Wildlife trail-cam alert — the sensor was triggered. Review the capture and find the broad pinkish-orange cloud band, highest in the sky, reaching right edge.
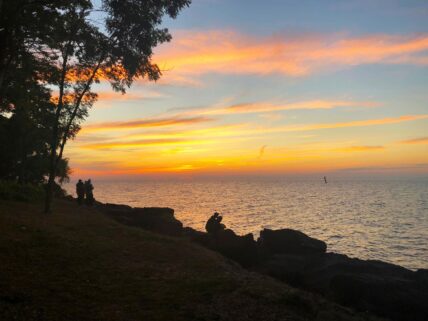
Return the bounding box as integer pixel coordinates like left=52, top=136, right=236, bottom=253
left=155, top=30, right=428, bottom=77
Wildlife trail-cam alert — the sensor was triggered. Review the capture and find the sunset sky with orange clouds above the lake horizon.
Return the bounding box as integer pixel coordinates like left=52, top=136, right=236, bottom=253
left=65, top=0, right=428, bottom=178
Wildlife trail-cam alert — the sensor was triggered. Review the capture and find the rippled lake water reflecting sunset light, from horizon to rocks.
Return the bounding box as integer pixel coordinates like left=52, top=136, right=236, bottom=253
left=66, top=179, right=428, bottom=269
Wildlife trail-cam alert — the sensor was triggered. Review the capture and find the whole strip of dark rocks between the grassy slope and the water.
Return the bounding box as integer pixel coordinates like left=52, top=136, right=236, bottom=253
left=90, top=203, right=428, bottom=321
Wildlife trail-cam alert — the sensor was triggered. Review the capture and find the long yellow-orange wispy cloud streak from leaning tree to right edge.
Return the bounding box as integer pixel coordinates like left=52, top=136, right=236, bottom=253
left=77, top=115, right=428, bottom=143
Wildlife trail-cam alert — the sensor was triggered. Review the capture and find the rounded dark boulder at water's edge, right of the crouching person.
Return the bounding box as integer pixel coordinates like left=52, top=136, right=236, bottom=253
left=258, top=229, right=327, bottom=255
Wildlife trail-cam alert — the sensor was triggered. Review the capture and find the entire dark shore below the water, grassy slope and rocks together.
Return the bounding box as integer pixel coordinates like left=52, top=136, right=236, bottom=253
left=0, top=196, right=428, bottom=321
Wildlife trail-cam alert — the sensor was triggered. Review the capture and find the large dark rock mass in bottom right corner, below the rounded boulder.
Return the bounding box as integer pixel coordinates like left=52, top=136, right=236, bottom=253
left=259, top=253, right=428, bottom=321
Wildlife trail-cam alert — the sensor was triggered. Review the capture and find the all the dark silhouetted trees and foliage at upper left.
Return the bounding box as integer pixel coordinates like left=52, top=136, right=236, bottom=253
left=0, top=0, right=190, bottom=211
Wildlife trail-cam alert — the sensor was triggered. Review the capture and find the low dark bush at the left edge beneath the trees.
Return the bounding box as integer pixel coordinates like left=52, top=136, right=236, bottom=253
left=0, top=181, right=45, bottom=202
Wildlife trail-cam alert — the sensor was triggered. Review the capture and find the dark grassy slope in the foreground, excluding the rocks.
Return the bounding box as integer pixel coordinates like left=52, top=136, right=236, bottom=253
left=0, top=201, right=382, bottom=321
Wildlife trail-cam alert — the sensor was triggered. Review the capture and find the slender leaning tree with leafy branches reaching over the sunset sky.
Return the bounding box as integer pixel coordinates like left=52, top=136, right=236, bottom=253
left=44, top=0, right=190, bottom=212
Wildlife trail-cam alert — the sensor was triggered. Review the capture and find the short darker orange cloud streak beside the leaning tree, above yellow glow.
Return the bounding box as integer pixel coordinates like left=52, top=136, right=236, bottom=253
left=82, top=117, right=212, bottom=132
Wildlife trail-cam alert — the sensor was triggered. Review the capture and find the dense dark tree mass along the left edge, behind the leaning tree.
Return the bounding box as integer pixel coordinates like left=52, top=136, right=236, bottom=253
left=0, top=0, right=81, bottom=183
